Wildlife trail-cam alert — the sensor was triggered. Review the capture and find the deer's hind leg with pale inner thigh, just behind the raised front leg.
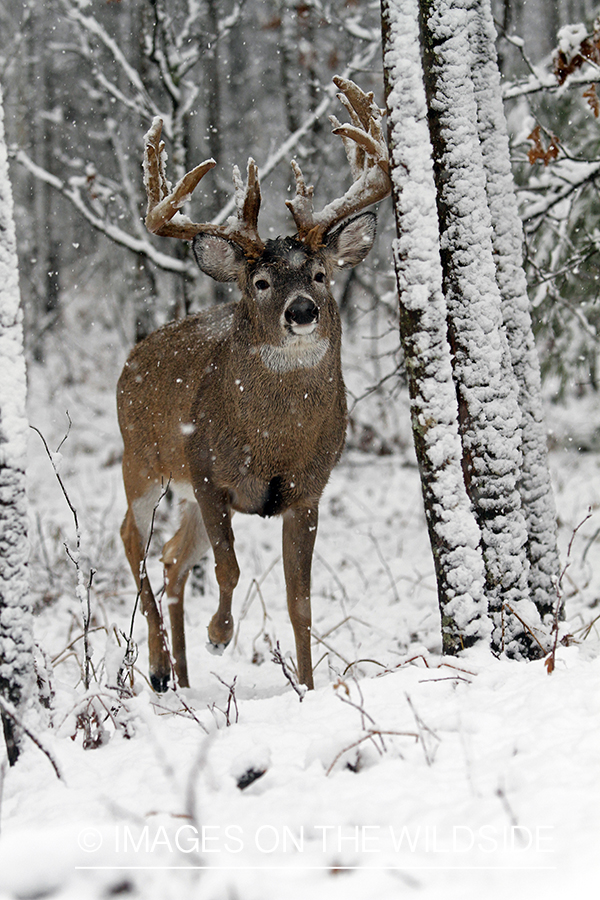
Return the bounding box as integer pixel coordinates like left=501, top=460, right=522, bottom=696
left=162, top=500, right=210, bottom=687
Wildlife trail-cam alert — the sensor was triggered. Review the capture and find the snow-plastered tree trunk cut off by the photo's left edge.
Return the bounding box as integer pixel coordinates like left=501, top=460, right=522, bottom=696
left=0, top=89, right=33, bottom=764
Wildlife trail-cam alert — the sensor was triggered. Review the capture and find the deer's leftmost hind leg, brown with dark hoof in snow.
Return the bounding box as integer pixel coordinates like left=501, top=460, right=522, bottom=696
left=121, top=484, right=171, bottom=693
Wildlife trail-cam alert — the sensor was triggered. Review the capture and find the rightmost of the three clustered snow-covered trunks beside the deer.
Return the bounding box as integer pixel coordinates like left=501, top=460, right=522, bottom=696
left=470, top=0, right=559, bottom=615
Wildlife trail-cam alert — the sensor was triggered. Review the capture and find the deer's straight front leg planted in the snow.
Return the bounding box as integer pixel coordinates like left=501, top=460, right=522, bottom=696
left=283, top=506, right=319, bottom=690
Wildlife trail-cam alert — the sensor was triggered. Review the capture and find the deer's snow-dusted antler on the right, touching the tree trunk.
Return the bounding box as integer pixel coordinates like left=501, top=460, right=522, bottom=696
left=286, top=76, right=391, bottom=247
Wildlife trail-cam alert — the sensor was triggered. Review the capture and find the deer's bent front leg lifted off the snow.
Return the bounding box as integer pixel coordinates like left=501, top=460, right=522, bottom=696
left=196, top=482, right=240, bottom=649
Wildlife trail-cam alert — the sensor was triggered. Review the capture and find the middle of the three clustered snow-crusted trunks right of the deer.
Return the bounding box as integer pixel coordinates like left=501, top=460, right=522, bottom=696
left=420, top=0, right=539, bottom=656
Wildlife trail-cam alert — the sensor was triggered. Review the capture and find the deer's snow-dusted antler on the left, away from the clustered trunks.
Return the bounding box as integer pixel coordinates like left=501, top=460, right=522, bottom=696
left=144, top=117, right=264, bottom=258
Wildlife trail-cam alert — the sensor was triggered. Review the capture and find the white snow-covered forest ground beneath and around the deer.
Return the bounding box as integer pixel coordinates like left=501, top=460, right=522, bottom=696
left=0, top=276, right=600, bottom=900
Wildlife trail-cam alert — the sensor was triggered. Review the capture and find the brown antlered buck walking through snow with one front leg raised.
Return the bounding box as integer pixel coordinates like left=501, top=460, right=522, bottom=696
left=117, top=77, right=390, bottom=693
